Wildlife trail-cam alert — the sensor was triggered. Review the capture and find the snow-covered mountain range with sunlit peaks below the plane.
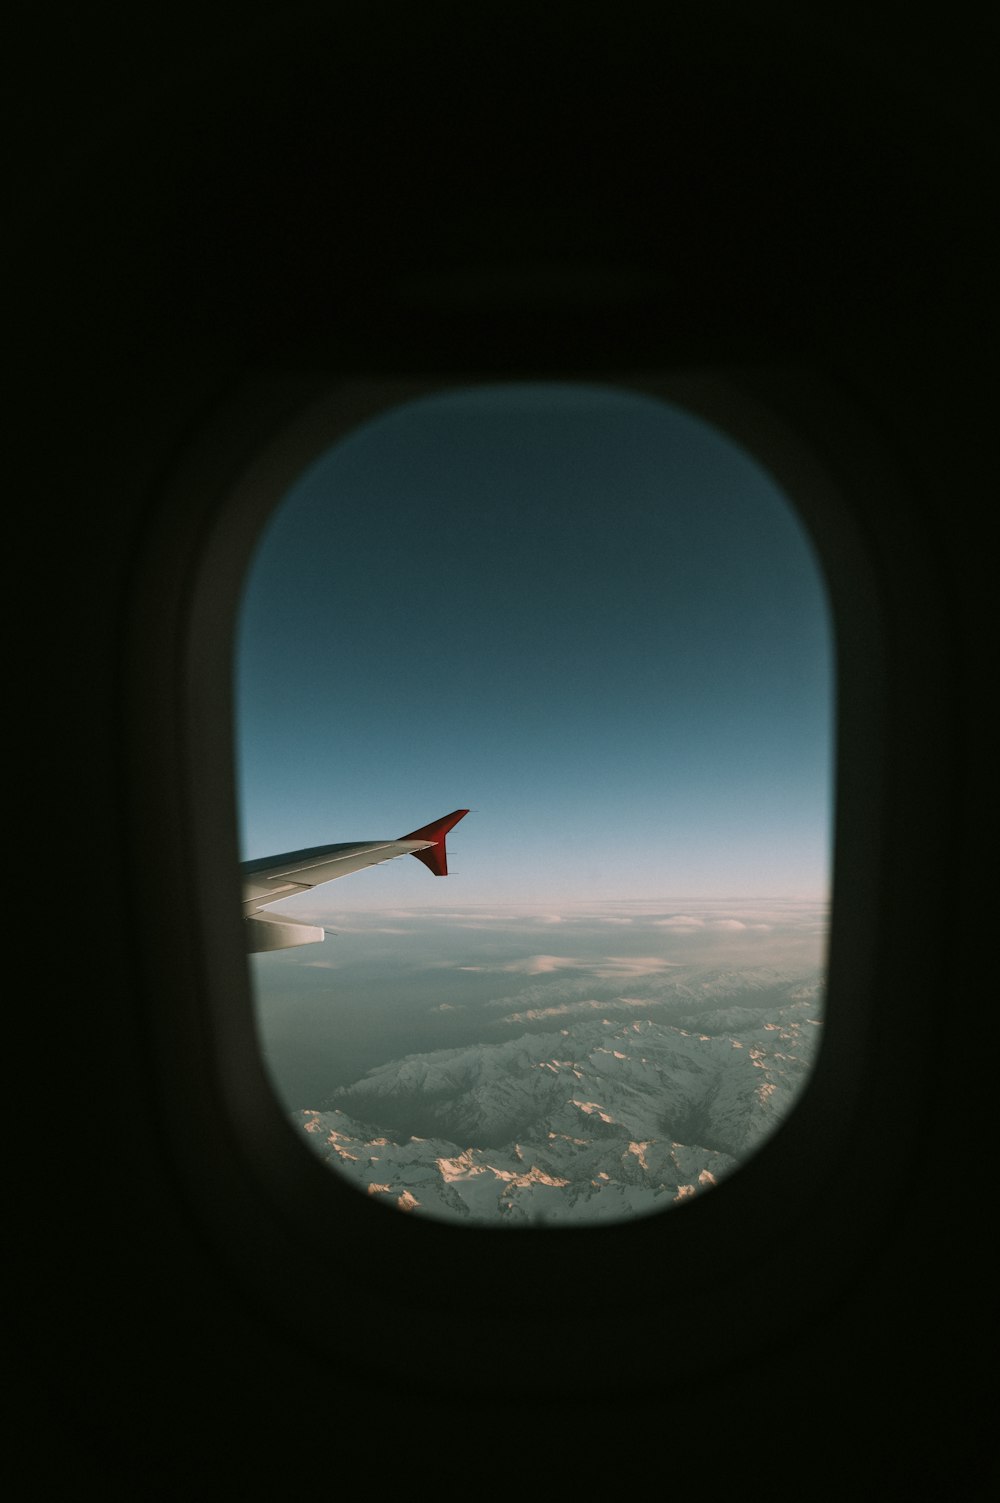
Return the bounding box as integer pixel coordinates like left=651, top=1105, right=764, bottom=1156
left=295, top=972, right=821, bottom=1225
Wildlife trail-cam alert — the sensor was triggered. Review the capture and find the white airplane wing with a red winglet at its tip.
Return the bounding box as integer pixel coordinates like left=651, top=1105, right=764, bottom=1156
left=241, top=809, right=469, bottom=953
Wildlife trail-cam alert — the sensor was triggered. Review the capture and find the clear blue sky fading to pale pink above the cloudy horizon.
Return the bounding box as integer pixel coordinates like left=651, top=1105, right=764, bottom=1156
left=236, top=385, right=833, bottom=912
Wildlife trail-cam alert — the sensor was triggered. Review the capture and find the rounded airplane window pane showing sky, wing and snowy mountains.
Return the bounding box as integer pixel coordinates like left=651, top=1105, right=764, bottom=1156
left=236, top=383, right=835, bottom=1226
